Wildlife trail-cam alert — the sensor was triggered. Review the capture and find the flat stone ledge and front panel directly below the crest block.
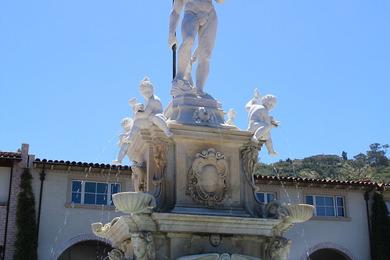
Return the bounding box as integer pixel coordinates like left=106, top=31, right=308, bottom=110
left=152, top=213, right=281, bottom=259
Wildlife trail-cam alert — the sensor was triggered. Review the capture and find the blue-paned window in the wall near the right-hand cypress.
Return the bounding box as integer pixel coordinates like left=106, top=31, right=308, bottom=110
left=306, top=195, right=345, bottom=217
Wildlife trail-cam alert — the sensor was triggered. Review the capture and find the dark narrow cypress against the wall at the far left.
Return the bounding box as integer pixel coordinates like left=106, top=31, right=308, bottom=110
left=14, top=168, right=38, bottom=260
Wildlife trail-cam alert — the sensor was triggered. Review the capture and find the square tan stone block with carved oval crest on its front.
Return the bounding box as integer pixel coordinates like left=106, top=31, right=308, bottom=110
left=165, top=123, right=254, bottom=217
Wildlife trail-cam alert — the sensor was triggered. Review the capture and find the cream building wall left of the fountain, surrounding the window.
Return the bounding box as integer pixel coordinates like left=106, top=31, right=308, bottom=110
left=33, top=169, right=131, bottom=260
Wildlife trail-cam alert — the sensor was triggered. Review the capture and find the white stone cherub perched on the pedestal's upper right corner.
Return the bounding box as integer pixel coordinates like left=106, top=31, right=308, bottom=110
left=245, top=90, right=279, bottom=156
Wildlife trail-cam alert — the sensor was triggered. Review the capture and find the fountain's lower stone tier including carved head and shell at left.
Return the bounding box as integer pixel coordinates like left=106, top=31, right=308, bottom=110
left=92, top=205, right=290, bottom=260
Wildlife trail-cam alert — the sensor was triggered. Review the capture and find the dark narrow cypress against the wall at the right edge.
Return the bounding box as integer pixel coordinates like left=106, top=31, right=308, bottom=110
left=371, top=192, right=390, bottom=260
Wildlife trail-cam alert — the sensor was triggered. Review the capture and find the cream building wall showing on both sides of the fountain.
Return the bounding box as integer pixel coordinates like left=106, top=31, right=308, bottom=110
left=33, top=172, right=370, bottom=260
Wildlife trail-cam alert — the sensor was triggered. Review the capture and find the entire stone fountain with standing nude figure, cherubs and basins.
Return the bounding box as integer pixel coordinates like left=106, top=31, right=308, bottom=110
left=92, top=0, right=314, bottom=260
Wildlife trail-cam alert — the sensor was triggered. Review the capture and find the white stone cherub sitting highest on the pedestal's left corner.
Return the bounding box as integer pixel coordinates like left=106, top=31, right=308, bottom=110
left=126, top=77, right=172, bottom=142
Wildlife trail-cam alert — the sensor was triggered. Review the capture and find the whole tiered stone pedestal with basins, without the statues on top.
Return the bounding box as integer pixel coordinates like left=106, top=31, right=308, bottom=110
left=92, top=88, right=314, bottom=260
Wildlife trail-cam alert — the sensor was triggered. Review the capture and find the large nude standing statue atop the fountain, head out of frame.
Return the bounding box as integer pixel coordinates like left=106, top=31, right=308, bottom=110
left=168, top=0, right=224, bottom=96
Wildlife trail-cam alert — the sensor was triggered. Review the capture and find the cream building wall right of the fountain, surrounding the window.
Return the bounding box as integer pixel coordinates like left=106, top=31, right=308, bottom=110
left=260, top=185, right=370, bottom=260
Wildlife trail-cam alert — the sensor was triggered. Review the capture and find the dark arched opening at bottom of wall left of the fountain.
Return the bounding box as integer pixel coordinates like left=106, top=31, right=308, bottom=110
left=58, top=240, right=112, bottom=260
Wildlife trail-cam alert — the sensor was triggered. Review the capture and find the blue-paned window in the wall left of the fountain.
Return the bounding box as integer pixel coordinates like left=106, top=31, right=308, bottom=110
left=71, top=180, right=121, bottom=205
